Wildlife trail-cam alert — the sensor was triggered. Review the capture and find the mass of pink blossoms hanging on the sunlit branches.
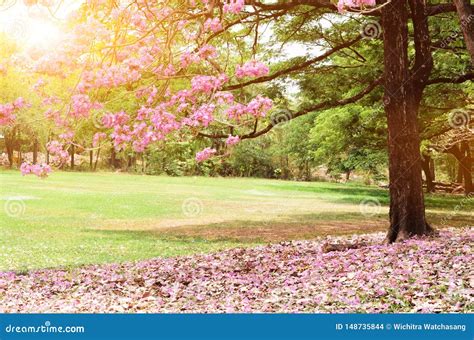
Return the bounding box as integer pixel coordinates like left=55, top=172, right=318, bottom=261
left=6, top=0, right=282, bottom=169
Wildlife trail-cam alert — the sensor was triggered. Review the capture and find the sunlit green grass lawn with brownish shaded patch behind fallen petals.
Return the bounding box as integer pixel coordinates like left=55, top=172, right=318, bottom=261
left=0, top=171, right=474, bottom=271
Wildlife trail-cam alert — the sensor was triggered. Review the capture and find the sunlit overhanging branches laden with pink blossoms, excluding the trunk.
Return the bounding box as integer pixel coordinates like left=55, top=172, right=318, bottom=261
left=0, top=0, right=386, bottom=176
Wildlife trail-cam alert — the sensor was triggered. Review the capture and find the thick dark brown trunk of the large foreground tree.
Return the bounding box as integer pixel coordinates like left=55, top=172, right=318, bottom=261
left=382, top=0, right=432, bottom=242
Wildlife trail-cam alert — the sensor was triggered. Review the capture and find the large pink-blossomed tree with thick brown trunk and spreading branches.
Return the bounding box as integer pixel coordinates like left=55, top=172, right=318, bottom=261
left=0, top=0, right=472, bottom=242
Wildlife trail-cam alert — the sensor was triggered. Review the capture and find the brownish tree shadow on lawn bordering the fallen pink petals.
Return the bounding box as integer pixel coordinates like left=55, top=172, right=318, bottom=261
left=87, top=209, right=472, bottom=249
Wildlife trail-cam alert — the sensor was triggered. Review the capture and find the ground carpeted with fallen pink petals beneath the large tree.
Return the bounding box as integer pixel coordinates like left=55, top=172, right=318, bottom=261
left=0, top=228, right=474, bottom=312
